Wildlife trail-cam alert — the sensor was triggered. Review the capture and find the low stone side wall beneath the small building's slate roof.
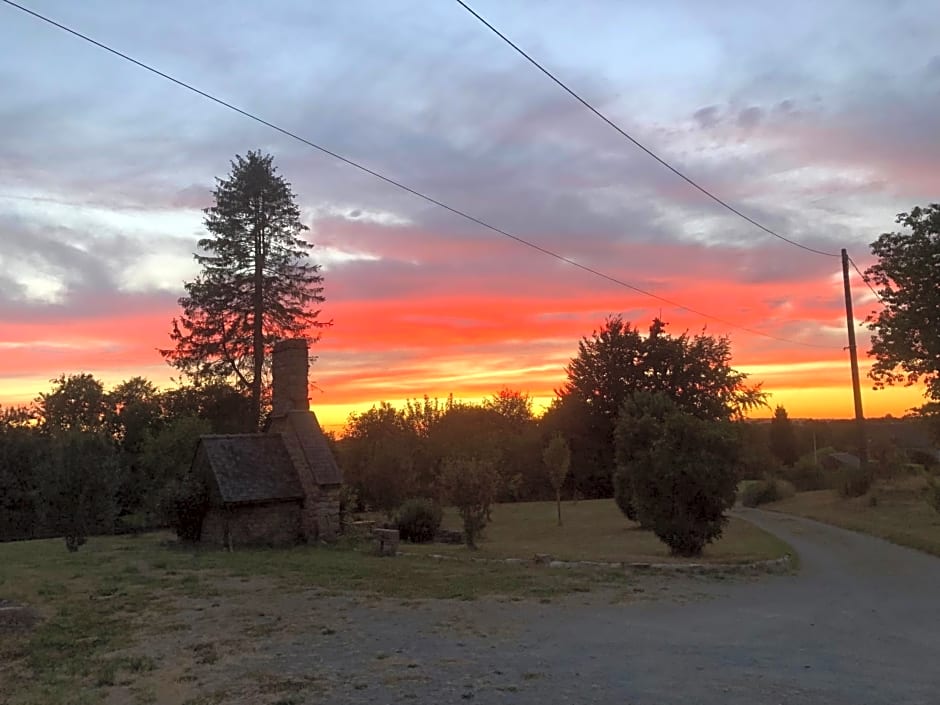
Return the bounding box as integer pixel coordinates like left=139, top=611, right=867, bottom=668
left=202, top=501, right=303, bottom=548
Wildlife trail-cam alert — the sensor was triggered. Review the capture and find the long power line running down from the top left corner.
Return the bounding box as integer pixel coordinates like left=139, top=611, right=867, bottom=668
left=0, top=0, right=833, bottom=349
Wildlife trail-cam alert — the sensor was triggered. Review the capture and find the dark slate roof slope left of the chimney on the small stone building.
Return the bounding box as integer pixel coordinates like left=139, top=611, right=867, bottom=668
left=196, top=433, right=304, bottom=504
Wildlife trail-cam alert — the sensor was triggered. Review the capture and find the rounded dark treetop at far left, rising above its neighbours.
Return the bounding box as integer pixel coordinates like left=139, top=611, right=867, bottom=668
left=35, top=373, right=108, bottom=433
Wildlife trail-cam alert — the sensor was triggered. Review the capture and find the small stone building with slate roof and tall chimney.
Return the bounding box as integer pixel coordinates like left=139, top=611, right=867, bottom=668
left=193, top=339, right=343, bottom=547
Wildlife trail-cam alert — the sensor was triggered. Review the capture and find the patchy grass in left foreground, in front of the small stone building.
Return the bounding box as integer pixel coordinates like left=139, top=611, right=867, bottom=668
left=0, top=533, right=629, bottom=705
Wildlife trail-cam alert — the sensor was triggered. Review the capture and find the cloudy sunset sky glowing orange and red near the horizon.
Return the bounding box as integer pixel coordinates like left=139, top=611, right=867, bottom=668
left=0, top=0, right=940, bottom=428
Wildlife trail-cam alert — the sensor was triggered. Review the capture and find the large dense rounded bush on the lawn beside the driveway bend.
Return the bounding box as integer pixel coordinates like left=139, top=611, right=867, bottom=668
left=616, top=394, right=740, bottom=556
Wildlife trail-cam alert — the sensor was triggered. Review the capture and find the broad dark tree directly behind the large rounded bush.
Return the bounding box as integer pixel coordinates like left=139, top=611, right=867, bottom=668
left=549, top=316, right=766, bottom=496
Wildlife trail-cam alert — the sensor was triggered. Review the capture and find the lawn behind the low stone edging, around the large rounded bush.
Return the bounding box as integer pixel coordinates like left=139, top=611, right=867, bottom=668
left=406, top=499, right=791, bottom=563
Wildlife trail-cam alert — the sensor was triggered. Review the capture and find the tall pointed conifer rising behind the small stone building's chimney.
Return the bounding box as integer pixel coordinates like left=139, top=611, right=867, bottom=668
left=161, top=152, right=324, bottom=427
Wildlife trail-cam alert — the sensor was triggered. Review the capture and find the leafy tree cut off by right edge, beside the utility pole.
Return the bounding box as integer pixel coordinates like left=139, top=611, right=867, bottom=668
left=866, top=203, right=940, bottom=402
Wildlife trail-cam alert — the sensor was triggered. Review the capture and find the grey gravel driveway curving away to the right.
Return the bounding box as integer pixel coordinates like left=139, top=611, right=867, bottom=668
left=140, top=510, right=940, bottom=705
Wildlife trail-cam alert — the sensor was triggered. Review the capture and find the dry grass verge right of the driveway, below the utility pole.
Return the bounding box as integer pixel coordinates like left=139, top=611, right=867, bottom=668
left=762, top=477, right=940, bottom=556
